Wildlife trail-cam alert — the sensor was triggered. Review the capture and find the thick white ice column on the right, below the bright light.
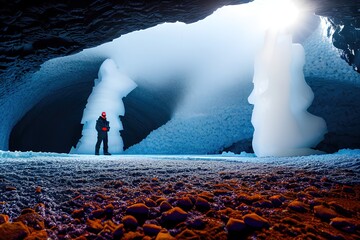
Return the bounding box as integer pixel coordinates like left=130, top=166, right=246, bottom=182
left=248, top=31, right=327, bottom=157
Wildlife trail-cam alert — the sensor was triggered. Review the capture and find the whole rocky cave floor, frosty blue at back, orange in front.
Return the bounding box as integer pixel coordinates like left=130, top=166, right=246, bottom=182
left=0, top=154, right=360, bottom=240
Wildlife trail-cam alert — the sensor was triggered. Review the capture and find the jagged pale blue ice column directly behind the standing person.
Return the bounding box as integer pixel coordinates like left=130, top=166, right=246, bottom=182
left=70, top=59, right=136, bottom=154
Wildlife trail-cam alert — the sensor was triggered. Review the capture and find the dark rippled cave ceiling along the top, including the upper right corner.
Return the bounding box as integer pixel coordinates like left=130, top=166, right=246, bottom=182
left=0, top=0, right=360, bottom=81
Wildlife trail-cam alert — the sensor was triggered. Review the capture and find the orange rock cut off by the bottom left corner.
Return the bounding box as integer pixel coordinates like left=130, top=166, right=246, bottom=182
left=0, top=222, right=30, bottom=240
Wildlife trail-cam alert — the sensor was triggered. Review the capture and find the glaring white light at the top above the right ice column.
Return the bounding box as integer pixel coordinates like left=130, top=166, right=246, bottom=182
left=258, top=0, right=300, bottom=30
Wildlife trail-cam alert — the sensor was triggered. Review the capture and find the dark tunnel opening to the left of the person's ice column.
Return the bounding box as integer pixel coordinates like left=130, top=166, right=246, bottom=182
left=9, top=82, right=93, bottom=153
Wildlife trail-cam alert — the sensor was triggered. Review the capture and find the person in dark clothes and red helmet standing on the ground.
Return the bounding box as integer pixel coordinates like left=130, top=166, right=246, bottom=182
left=95, top=112, right=111, bottom=155
